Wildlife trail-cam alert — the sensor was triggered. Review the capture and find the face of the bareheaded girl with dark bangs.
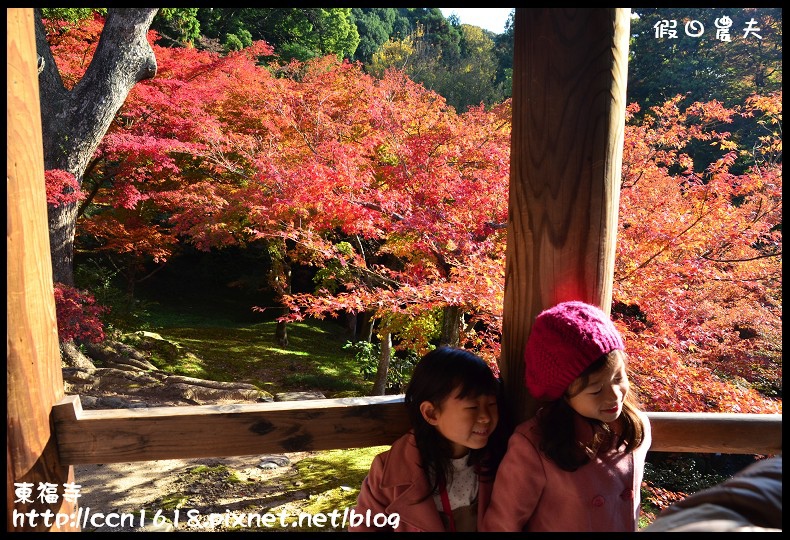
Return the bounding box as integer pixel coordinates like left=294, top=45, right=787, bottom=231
left=420, top=387, right=499, bottom=459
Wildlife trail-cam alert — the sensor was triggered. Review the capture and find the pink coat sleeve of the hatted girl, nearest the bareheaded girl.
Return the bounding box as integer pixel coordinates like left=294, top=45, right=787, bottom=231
left=479, top=429, right=546, bottom=532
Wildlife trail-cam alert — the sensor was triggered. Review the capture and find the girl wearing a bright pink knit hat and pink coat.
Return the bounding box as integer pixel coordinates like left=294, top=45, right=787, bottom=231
left=481, top=301, right=651, bottom=532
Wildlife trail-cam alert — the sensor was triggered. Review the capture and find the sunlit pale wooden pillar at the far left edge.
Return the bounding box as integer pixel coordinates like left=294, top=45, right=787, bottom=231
left=6, top=8, right=80, bottom=531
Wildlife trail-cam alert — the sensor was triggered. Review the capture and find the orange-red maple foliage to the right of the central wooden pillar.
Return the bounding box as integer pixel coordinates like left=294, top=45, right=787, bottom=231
left=614, top=94, right=782, bottom=412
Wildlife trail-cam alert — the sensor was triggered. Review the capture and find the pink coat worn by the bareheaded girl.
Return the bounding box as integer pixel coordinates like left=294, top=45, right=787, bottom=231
left=348, top=432, right=493, bottom=532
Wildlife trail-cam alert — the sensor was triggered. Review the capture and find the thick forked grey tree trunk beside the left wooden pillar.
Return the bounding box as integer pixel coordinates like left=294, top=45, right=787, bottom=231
left=35, top=8, right=159, bottom=285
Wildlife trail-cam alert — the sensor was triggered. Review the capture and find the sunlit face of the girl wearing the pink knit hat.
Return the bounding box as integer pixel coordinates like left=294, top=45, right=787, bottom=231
left=565, top=354, right=629, bottom=423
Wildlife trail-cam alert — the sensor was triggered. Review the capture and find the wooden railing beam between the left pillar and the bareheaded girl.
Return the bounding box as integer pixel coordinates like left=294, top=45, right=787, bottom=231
left=53, top=396, right=409, bottom=464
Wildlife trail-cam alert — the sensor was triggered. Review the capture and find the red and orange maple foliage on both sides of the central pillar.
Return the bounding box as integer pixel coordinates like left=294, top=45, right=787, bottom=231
left=56, top=16, right=782, bottom=412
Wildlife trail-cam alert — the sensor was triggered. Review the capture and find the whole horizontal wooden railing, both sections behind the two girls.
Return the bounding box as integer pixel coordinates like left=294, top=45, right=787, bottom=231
left=53, top=395, right=782, bottom=465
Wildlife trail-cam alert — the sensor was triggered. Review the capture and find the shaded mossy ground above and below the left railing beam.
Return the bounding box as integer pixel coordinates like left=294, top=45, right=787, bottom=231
left=64, top=262, right=383, bottom=532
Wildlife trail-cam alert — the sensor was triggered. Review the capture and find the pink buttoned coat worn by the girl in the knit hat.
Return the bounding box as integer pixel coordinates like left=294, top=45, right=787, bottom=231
left=479, top=414, right=652, bottom=532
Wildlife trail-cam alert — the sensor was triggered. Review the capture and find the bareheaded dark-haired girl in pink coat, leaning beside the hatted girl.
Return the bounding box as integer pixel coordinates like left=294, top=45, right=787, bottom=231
left=349, top=347, right=508, bottom=532
